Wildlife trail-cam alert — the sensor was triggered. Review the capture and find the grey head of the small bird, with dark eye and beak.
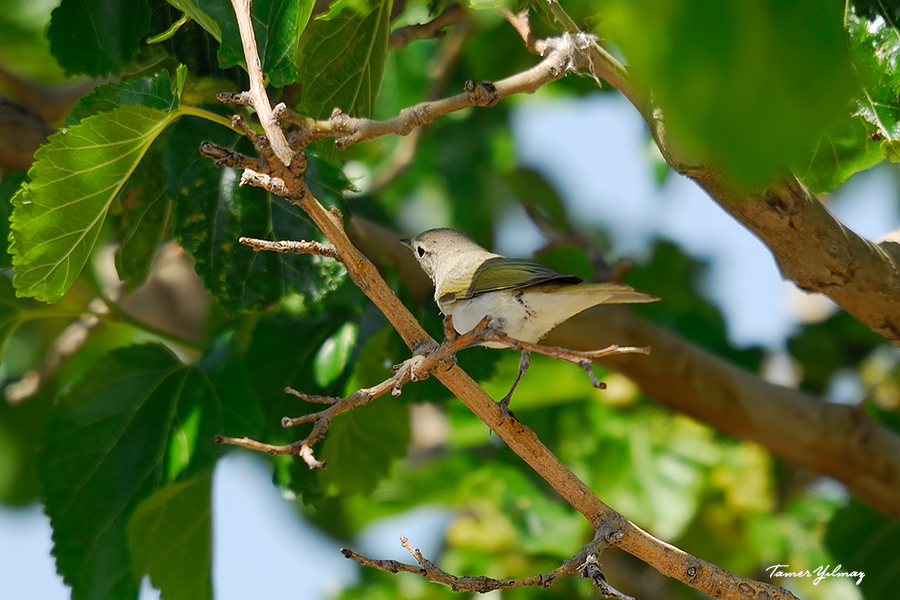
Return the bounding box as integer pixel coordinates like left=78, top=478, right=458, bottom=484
left=400, top=227, right=498, bottom=289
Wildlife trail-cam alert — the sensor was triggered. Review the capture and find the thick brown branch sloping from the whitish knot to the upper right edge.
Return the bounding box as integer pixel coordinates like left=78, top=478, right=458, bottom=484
left=589, top=15, right=900, bottom=344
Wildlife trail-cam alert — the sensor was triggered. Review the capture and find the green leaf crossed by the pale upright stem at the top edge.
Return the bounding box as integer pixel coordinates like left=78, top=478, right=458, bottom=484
left=169, top=0, right=315, bottom=87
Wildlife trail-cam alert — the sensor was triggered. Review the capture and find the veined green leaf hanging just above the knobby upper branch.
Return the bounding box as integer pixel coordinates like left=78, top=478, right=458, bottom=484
left=297, top=0, right=392, bottom=119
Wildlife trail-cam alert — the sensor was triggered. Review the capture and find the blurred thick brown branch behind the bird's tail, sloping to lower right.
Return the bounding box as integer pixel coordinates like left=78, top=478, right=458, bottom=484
left=547, top=306, right=900, bottom=515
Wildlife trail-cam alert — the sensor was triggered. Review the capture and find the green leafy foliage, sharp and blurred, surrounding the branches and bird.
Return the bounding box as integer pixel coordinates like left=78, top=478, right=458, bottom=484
left=0, top=0, right=900, bottom=600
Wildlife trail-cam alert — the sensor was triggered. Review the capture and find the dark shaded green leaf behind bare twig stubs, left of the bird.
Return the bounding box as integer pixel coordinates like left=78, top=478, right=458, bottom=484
left=165, top=120, right=344, bottom=313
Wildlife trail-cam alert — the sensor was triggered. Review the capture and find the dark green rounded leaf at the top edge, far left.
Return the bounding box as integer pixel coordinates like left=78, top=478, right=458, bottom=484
left=47, top=0, right=150, bottom=76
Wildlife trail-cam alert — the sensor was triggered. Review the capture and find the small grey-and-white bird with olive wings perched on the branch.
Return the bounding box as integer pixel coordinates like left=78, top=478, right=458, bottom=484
left=400, top=228, right=659, bottom=419
